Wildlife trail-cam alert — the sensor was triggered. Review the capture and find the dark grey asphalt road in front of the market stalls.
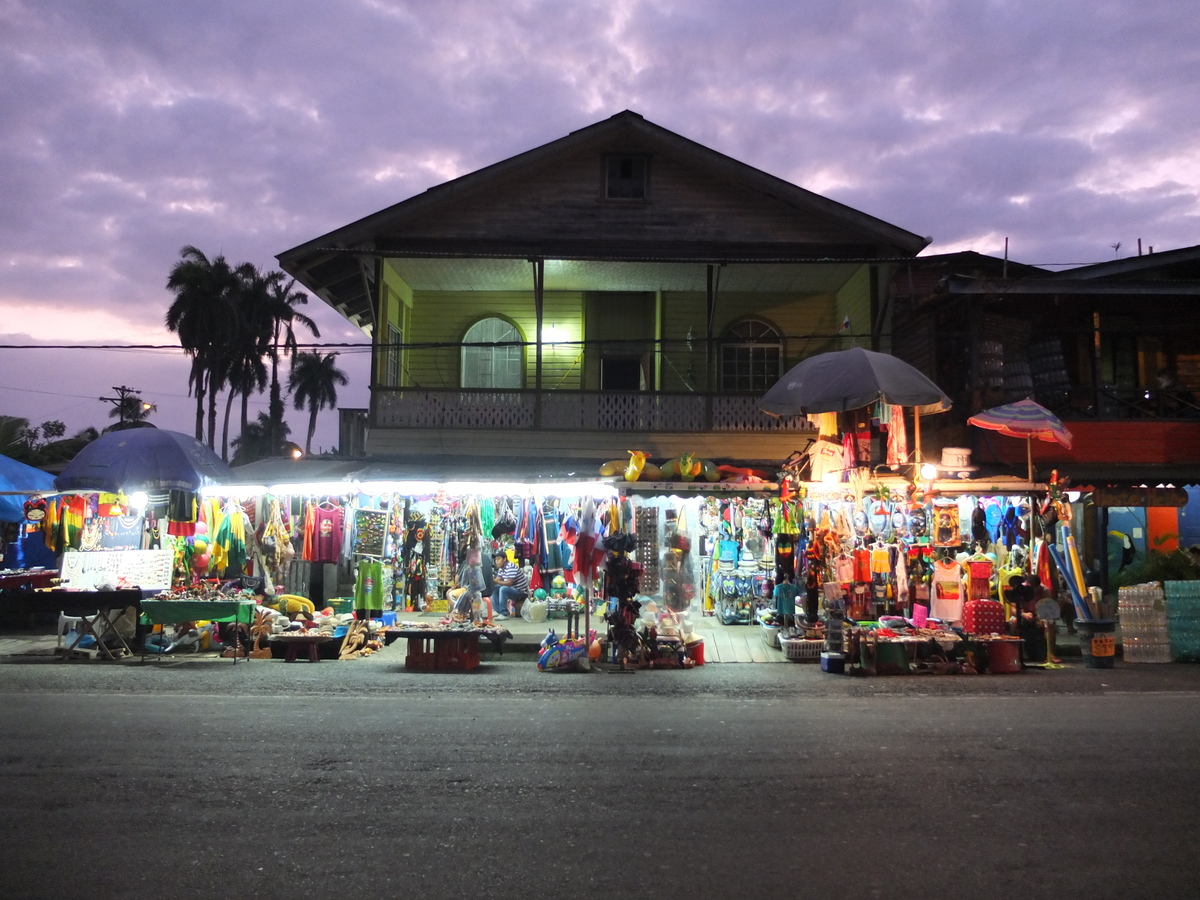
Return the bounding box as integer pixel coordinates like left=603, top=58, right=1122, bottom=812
left=0, top=649, right=1200, bottom=900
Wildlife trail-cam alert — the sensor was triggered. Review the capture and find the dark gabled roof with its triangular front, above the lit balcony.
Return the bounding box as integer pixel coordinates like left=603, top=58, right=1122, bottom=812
left=278, top=110, right=929, bottom=326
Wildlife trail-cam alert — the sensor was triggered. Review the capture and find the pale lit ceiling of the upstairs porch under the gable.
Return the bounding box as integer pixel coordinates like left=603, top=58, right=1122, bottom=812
left=386, top=257, right=860, bottom=293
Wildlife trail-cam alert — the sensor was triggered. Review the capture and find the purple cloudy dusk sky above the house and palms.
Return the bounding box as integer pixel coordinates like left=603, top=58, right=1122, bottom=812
left=0, top=0, right=1200, bottom=448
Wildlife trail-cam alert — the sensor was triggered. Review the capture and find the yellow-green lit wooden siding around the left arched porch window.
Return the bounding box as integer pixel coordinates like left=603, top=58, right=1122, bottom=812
left=404, top=290, right=583, bottom=389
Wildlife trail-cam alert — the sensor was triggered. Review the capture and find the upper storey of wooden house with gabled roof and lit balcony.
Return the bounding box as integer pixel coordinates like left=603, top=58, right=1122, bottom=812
left=278, top=112, right=929, bottom=461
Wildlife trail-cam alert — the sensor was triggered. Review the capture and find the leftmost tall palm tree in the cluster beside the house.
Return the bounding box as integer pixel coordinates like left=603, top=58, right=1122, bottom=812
left=167, top=245, right=240, bottom=448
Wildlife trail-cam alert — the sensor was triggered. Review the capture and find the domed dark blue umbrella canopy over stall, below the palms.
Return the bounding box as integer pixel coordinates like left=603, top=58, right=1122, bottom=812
left=54, top=428, right=233, bottom=493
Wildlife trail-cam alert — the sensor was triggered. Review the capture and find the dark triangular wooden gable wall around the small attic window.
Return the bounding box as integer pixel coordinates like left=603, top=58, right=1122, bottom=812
left=380, top=138, right=874, bottom=252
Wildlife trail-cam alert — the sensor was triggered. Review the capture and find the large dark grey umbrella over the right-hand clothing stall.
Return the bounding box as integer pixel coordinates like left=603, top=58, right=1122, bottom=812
left=758, top=347, right=950, bottom=463
